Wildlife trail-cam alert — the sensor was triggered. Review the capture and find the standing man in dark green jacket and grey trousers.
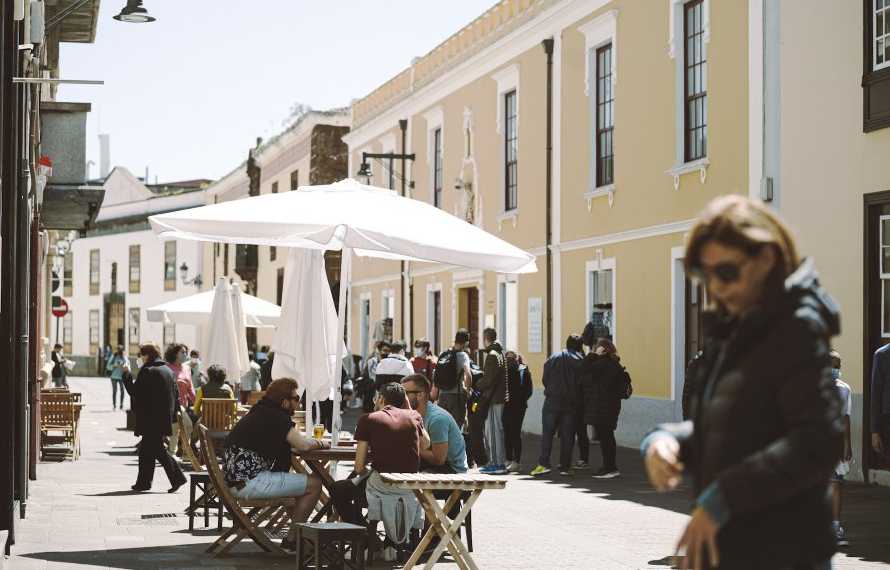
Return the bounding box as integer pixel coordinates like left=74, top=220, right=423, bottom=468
left=478, top=327, right=510, bottom=475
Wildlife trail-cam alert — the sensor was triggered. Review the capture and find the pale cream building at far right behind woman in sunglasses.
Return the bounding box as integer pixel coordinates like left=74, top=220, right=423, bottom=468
left=749, top=0, right=890, bottom=485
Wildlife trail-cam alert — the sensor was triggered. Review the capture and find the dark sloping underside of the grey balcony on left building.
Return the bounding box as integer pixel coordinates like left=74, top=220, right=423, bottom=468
left=40, top=184, right=105, bottom=231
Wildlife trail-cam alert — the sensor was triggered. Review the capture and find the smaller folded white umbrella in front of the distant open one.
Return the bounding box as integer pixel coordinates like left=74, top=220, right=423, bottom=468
left=202, top=277, right=248, bottom=378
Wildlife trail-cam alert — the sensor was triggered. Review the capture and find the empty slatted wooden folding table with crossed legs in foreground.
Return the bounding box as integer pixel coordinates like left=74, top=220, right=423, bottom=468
left=380, top=473, right=507, bottom=570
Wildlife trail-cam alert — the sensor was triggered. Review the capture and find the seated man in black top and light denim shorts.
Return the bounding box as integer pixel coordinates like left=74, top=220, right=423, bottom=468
left=222, top=374, right=330, bottom=550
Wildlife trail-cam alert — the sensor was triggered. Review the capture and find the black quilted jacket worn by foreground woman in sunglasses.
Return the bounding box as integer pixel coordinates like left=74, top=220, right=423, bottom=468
left=668, top=260, right=843, bottom=570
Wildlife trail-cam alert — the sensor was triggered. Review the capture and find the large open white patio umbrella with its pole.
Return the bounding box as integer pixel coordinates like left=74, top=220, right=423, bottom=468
left=149, top=180, right=537, bottom=440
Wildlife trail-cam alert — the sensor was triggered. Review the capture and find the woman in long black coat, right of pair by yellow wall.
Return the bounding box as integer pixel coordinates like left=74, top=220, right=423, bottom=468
left=578, top=338, right=624, bottom=479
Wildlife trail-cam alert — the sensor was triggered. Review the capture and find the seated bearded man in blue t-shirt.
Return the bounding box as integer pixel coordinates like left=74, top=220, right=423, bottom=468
left=402, top=374, right=467, bottom=473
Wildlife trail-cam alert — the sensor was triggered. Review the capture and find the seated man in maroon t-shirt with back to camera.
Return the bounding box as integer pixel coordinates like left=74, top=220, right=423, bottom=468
left=331, top=382, right=430, bottom=523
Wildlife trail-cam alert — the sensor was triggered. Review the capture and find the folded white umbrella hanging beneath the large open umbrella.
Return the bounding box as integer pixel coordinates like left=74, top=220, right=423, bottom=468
left=272, top=249, right=343, bottom=401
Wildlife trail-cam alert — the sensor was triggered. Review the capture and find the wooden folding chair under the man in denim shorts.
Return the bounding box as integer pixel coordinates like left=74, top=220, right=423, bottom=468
left=198, top=425, right=296, bottom=556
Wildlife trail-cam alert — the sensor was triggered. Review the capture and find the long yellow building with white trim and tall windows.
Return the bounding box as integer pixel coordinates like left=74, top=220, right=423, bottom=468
left=344, top=0, right=749, bottom=445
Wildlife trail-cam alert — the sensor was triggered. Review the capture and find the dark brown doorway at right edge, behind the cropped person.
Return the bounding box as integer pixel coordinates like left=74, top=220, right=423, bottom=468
left=862, top=191, right=890, bottom=472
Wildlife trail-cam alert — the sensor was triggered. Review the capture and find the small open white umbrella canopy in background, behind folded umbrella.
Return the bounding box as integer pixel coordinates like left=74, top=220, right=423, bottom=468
left=146, top=290, right=281, bottom=327
